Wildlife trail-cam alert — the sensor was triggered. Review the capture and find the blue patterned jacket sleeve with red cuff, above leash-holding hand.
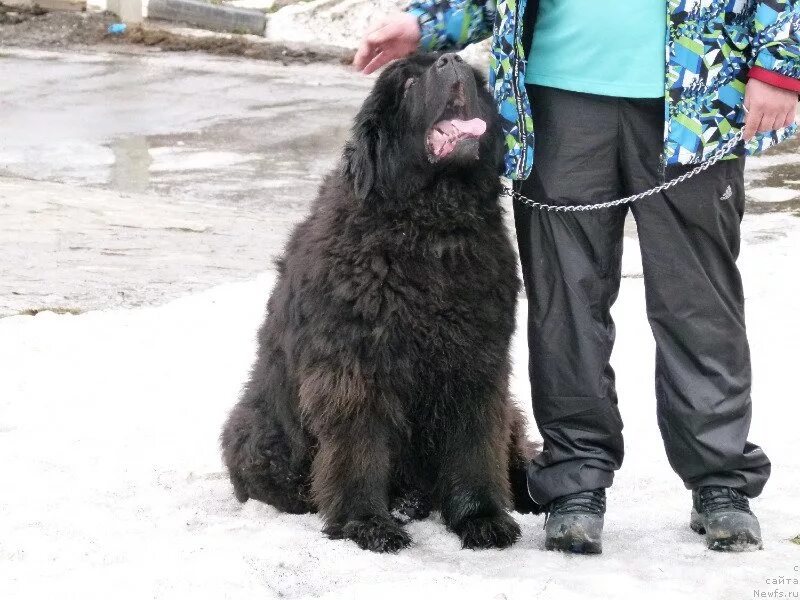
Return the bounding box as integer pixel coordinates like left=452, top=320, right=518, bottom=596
left=750, top=0, right=800, bottom=87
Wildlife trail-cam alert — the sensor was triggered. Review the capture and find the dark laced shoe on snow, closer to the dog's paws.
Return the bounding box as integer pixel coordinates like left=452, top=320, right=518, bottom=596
left=544, top=489, right=606, bottom=554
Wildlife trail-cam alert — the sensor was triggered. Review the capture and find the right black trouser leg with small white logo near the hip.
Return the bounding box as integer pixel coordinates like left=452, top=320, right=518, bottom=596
left=622, top=102, right=770, bottom=497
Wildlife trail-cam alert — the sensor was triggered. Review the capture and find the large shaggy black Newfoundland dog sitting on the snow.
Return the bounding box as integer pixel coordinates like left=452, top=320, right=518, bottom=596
left=222, top=54, right=534, bottom=551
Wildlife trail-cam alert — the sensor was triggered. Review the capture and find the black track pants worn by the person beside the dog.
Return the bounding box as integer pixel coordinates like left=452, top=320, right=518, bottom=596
left=514, top=86, right=770, bottom=504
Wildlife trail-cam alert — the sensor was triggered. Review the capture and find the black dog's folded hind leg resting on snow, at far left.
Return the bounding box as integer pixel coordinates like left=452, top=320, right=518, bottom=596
left=221, top=399, right=313, bottom=513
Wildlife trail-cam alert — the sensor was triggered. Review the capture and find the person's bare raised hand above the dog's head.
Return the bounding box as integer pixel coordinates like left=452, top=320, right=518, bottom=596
left=353, top=13, right=420, bottom=75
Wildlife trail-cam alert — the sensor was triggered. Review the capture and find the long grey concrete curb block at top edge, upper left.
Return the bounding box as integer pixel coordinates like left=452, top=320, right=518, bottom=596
left=152, top=0, right=267, bottom=37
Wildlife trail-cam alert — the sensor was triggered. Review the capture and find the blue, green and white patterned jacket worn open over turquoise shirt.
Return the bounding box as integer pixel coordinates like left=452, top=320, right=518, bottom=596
left=407, top=0, right=800, bottom=179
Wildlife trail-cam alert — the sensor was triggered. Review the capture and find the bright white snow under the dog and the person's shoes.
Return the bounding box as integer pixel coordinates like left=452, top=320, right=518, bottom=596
left=0, top=215, right=800, bottom=600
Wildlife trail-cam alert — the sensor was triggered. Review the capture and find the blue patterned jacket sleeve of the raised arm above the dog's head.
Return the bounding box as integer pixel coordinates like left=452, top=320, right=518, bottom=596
left=406, top=0, right=494, bottom=50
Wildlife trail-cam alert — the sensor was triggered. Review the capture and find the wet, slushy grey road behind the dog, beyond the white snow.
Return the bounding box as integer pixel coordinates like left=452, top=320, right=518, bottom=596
left=0, top=47, right=800, bottom=316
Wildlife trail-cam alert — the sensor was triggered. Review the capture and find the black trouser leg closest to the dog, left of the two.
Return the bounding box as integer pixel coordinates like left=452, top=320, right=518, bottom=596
left=514, top=86, right=626, bottom=506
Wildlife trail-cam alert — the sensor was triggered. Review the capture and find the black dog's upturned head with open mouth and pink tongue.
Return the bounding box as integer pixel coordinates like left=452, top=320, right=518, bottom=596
left=344, top=54, right=502, bottom=198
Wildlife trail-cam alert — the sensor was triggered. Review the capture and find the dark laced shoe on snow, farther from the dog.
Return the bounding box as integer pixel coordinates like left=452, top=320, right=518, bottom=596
left=689, top=485, right=764, bottom=552
